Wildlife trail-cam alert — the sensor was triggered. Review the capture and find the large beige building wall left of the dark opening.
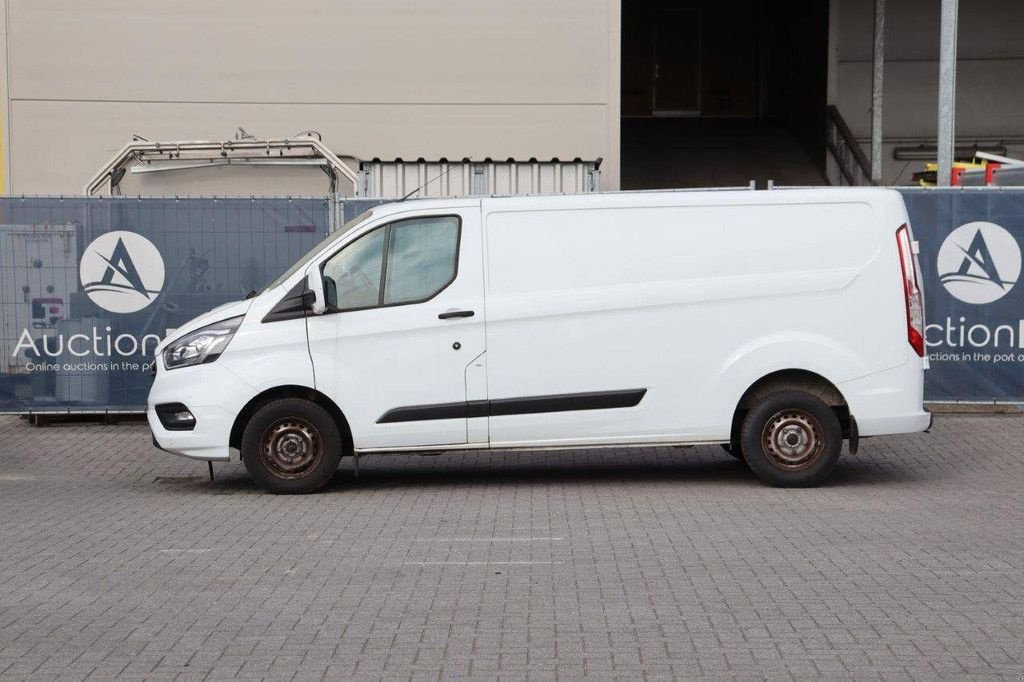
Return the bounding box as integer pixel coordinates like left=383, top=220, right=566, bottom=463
left=0, top=0, right=620, bottom=195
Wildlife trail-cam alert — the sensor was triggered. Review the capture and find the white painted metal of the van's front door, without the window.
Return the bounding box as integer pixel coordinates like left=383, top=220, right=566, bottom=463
left=306, top=200, right=486, bottom=450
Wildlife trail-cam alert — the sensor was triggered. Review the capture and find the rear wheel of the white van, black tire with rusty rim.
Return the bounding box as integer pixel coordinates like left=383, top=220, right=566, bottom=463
left=740, top=390, right=843, bottom=487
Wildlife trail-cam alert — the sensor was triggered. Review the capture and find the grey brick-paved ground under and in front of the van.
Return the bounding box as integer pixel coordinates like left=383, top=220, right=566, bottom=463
left=0, top=416, right=1024, bottom=679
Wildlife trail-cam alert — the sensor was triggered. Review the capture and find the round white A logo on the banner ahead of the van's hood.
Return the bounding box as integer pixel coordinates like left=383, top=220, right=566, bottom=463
left=79, top=230, right=164, bottom=312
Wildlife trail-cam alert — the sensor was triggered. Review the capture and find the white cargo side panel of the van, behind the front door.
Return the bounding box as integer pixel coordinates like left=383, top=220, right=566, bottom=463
left=482, top=189, right=921, bottom=447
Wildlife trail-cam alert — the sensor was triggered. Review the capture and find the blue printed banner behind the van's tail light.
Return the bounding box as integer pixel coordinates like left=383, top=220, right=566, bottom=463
left=901, top=188, right=1024, bottom=402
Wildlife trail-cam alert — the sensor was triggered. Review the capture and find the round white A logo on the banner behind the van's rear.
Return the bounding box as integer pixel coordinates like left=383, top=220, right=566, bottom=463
left=937, top=221, right=1021, bottom=304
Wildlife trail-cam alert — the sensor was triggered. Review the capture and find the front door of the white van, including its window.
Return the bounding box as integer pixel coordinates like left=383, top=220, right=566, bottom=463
left=306, top=201, right=486, bottom=451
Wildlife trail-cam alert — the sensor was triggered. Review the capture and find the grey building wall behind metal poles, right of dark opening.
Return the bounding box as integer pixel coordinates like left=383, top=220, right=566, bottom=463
left=830, top=0, right=1024, bottom=183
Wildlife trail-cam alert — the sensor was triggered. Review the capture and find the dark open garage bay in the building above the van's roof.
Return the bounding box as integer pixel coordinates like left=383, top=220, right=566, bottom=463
left=622, top=0, right=828, bottom=189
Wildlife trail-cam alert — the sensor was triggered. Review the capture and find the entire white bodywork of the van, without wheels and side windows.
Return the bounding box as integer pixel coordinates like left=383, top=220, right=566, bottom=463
left=150, top=188, right=930, bottom=460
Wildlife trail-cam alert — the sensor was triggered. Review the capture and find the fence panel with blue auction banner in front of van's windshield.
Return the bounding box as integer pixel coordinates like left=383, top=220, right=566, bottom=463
left=0, top=193, right=330, bottom=413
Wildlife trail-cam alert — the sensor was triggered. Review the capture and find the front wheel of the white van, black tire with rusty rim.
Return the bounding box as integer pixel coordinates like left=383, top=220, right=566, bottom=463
left=242, top=398, right=343, bottom=494
